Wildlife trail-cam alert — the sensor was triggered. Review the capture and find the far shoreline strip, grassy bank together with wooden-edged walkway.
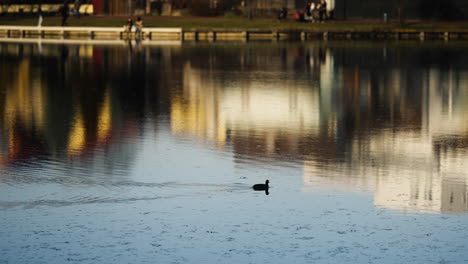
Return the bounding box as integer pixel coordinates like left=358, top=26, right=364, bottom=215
left=0, top=16, right=468, bottom=41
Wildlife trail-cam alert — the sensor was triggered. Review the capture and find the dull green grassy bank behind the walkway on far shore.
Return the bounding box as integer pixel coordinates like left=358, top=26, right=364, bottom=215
left=0, top=16, right=468, bottom=31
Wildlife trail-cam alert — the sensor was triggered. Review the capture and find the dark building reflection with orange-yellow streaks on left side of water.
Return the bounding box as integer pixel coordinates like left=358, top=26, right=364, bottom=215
left=0, top=42, right=180, bottom=175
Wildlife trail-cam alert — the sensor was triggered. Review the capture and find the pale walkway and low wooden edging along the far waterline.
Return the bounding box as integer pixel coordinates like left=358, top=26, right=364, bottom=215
left=0, top=26, right=468, bottom=41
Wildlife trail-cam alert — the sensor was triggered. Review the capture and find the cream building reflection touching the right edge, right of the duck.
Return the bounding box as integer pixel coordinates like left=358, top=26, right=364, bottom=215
left=304, top=65, right=468, bottom=213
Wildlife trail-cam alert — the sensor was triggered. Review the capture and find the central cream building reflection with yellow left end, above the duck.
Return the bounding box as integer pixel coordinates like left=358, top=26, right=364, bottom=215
left=170, top=50, right=320, bottom=159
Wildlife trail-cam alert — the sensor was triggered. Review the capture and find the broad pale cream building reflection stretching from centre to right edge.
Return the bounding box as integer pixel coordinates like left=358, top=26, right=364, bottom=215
left=171, top=46, right=468, bottom=213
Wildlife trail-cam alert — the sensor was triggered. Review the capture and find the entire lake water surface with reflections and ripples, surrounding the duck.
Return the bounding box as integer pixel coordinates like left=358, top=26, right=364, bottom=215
left=0, top=42, right=468, bottom=263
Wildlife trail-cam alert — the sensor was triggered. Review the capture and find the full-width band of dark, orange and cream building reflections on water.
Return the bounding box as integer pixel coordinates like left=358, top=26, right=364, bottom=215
left=0, top=43, right=468, bottom=213
